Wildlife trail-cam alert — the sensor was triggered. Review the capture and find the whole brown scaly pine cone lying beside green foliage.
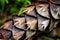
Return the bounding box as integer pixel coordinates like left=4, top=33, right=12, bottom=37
left=0, top=0, right=60, bottom=40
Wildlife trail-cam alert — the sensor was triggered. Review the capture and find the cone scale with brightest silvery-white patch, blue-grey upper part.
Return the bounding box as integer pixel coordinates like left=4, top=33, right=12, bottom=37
left=38, top=15, right=50, bottom=31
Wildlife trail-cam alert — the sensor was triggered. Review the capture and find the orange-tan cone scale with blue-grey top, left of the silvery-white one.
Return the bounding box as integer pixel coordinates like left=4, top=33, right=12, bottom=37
left=26, top=16, right=37, bottom=30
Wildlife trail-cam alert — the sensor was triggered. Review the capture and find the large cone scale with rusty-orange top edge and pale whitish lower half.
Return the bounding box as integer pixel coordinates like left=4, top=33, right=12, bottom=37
left=36, top=4, right=50, bottom=18
